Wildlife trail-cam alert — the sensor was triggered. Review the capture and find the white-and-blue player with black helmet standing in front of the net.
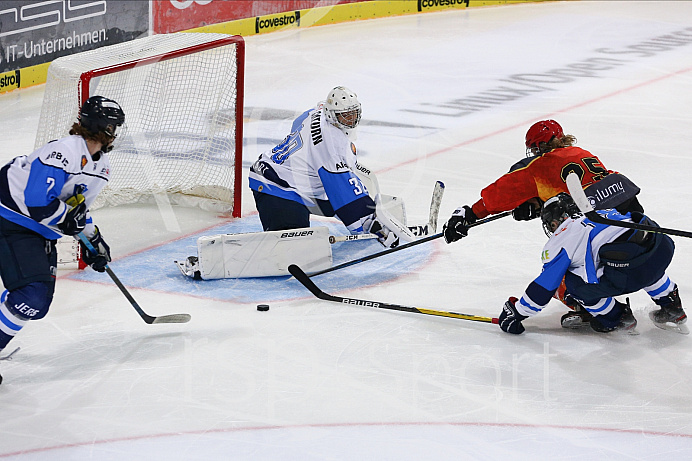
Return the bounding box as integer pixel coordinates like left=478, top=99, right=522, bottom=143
left=0, top=96, right=125, bottom=380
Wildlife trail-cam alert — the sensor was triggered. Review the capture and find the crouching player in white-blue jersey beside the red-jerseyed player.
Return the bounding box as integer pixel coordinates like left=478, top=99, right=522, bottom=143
left=499, top=193, right=687, bottom=334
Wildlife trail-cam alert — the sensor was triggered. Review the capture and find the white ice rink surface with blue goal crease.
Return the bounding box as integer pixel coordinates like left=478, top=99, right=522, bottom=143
left=0, top=1, right=692, bottom=461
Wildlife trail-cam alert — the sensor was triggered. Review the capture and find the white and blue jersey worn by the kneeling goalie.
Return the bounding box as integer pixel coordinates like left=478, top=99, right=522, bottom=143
left=249, top=103, right=375, bottom=233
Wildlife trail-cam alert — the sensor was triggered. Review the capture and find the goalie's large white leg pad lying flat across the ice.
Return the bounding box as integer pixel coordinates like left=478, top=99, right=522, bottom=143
left=197, top=227, right=332, bottom=280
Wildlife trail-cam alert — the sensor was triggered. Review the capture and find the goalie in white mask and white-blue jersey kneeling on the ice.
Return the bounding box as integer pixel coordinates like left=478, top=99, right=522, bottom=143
left=249, top=87, right=413, bottom=247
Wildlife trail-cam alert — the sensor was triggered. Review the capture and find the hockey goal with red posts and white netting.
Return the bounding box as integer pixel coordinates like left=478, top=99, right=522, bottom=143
left=35, top=33, right=245, bottom=217
